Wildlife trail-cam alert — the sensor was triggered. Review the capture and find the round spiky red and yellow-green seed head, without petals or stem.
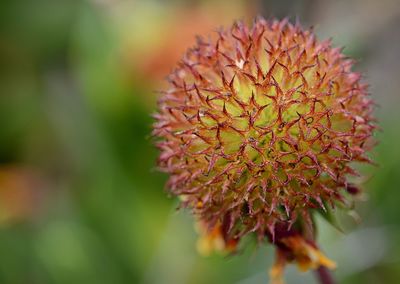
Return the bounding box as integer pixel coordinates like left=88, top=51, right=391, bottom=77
left=154, top=18, right=375, bottom=242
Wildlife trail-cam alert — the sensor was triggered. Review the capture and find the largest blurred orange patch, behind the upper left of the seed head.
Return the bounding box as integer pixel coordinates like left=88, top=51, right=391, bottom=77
left=120, top=1, right=257, bottom=87
